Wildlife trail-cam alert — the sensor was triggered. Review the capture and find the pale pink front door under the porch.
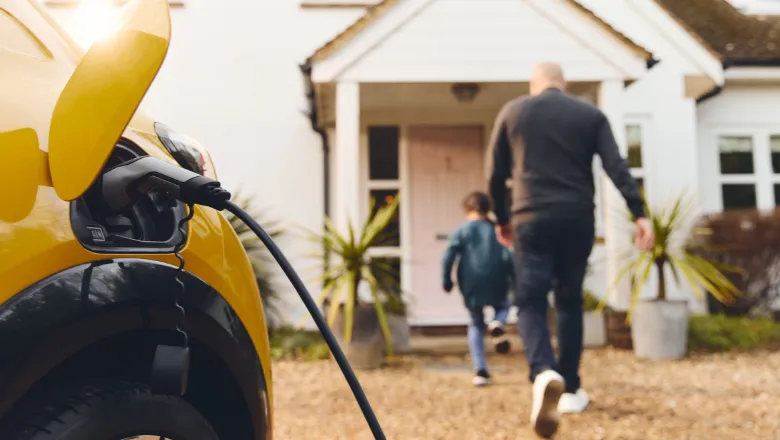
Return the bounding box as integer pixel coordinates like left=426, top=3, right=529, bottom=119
left=408, top=126, right=486, bottom=325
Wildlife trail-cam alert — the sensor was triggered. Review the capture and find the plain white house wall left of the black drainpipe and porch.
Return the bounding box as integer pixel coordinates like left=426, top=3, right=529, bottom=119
left=45, top=0, right=361, bottom=324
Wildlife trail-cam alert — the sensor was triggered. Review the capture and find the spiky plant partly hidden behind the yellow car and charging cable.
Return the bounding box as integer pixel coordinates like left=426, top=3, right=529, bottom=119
left=225, top=190, right=284, bottom=330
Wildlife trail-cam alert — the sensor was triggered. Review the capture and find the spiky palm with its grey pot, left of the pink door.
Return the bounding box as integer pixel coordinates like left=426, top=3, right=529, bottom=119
left=308, top=197, right=400, bottom=369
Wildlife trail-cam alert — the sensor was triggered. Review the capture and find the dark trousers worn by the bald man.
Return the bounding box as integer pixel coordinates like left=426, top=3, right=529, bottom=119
left=514, top=219, right=594, bottom=393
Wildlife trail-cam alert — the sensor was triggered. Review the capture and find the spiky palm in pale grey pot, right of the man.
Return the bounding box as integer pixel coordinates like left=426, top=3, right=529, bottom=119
left=599, top=195, right=741, bottom=360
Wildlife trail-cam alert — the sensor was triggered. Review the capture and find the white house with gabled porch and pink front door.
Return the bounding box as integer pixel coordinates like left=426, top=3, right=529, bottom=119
left=44, top=0, right=780, bottom=325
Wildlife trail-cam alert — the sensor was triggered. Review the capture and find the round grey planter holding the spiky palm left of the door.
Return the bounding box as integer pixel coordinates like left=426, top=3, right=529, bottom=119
left=331, top=304, right=385, bottom=370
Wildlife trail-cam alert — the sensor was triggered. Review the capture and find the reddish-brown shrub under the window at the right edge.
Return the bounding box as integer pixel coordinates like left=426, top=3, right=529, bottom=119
left=689, top=210, right=780, bottom=318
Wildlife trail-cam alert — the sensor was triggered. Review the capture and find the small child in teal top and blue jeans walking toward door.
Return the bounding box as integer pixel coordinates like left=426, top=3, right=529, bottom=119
left=442, top=192, right=514, bottom=386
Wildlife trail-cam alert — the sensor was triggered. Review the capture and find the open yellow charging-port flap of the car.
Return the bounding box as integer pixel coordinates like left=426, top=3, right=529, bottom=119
left=48, top=0, right=171, bottom=201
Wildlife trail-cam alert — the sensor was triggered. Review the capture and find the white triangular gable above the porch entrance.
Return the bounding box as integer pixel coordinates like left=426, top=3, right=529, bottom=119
left=308, top=0, right=652, bottom=82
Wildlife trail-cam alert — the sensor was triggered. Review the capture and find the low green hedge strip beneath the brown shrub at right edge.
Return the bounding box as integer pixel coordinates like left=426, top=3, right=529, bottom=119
left=688, top=315, right=780, bottom=352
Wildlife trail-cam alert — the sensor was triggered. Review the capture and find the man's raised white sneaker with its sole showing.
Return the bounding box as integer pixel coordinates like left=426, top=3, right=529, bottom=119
left=531, top=370, right=564, bottom=438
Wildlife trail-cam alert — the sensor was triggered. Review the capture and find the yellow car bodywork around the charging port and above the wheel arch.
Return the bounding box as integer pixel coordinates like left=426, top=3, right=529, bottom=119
left=0, top=0, right=272, bottom=430
